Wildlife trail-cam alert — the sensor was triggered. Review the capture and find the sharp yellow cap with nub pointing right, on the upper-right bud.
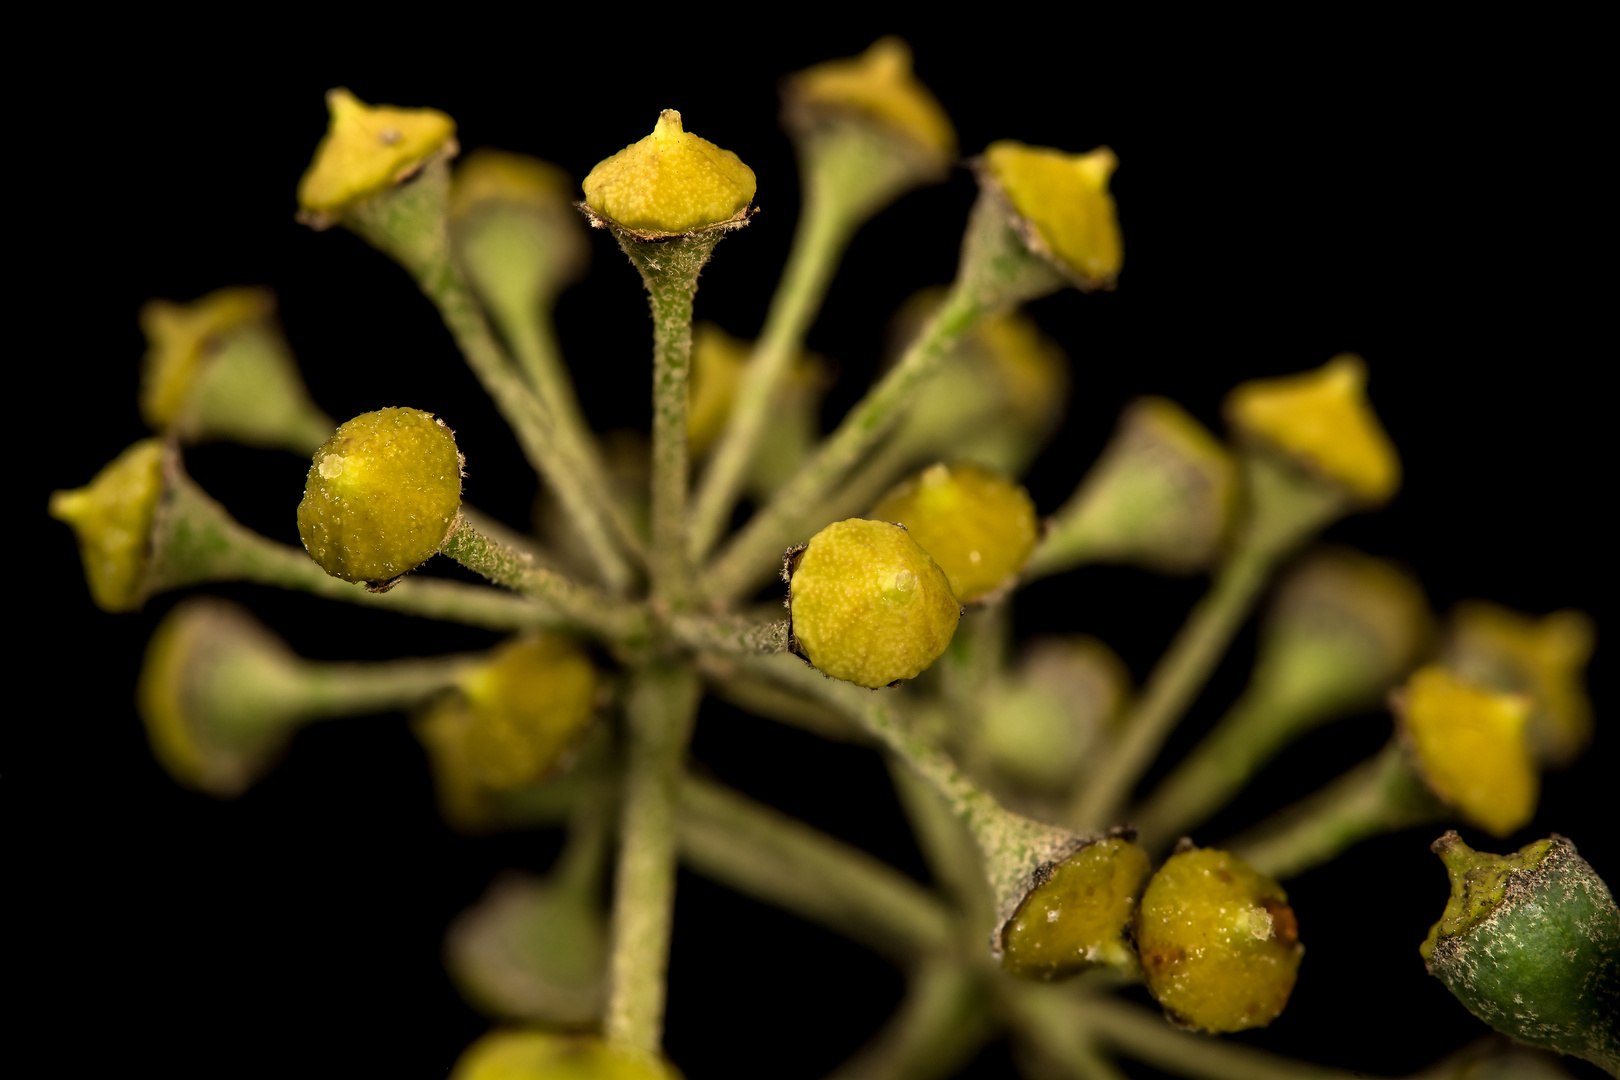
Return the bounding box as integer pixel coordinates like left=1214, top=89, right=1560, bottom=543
left=983, top=139, right=1124, bottom=290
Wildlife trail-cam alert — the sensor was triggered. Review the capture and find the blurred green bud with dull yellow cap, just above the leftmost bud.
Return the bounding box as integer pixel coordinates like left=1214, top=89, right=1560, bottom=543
left=141, top=288, right=335, bottom=453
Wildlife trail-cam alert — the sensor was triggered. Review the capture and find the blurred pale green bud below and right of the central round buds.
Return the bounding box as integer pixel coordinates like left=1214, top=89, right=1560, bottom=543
left=977, top=635, right=1131, bottom=793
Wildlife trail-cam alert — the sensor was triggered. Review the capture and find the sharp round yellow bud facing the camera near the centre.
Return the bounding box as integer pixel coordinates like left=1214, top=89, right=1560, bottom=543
left=789, top=518, right=961, bottom=690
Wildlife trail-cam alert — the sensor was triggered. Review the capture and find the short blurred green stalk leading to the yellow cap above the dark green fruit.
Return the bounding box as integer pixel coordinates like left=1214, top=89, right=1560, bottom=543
left=1223, top=742, right=1447, bottom=878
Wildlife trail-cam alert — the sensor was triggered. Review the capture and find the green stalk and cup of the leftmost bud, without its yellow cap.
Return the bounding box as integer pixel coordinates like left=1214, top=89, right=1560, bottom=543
left=143, top=453, right=563, bottom=630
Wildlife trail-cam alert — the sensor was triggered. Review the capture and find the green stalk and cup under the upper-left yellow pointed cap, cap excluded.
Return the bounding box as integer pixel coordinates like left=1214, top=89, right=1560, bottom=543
left=343, top=159, right=632, bottom=591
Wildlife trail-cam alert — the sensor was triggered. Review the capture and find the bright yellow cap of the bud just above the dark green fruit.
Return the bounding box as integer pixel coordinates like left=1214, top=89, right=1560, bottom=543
left=1395, top=664, right=1541, bottom=837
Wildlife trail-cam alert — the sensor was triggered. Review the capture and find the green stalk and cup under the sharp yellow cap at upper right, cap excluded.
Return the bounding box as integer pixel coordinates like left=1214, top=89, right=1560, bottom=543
left=698, top=187, right=1063, bottom=604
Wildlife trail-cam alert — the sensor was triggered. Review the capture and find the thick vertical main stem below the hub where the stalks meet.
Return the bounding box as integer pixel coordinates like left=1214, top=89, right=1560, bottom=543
left=603, top=667, right=698, bottom=1052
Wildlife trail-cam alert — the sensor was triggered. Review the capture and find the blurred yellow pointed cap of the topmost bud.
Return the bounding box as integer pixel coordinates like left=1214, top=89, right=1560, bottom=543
left=782, top=36, right=956, bottom=168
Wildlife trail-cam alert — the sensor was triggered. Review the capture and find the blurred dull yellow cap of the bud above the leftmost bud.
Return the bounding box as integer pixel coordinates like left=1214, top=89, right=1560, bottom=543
left=141, top=288, right=275, bottom=431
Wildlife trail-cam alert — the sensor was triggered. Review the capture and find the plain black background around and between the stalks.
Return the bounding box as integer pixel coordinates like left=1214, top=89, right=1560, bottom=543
left=12, top=16, right=1620, bottom=1080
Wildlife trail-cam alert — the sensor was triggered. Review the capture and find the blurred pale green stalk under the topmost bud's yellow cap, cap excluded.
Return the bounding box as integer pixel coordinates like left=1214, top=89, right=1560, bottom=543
left=687, top=133, right=893, bottom=563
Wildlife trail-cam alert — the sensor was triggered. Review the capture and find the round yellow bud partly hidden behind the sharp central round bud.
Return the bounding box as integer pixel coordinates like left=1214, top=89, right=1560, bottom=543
left=868, top=465, right=1037, bottom=604
